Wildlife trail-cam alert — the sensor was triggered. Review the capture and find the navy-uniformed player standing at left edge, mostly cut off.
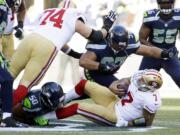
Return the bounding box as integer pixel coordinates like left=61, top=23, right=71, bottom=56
left=0, top=0, right=26, bottom=127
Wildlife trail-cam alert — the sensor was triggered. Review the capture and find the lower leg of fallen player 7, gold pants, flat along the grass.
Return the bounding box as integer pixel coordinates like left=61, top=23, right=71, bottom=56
left=55, top=101, right=117, bottom=126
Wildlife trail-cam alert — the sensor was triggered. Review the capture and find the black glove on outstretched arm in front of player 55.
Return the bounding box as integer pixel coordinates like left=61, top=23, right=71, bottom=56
left=161, top=48, right=178, bottom=60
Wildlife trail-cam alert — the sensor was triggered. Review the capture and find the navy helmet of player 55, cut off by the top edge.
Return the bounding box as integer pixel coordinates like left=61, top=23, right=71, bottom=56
left=157, top=0, right=175, bottom=14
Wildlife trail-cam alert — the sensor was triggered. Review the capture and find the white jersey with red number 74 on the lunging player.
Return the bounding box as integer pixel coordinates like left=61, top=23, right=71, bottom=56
left=35, top=8, right=86, bottom=49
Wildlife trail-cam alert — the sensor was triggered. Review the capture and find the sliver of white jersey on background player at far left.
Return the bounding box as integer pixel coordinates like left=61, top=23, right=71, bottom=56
left=4, top=10, right=15, bottom=35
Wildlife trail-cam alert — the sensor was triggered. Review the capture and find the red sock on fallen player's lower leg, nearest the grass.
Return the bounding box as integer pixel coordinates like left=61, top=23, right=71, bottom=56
left=56, top=103, right=78, bottom=119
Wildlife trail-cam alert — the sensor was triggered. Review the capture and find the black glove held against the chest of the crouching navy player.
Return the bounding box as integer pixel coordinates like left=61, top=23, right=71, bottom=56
left=98, top=63, right=119, bottom=74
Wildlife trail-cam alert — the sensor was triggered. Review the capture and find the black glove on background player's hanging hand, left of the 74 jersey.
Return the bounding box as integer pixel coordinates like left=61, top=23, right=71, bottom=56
left=14, top=21, right=23, bottom=39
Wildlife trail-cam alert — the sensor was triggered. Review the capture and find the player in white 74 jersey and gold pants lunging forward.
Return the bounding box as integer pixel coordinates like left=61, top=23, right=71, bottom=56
left=10, top=8, right=116, bottom=105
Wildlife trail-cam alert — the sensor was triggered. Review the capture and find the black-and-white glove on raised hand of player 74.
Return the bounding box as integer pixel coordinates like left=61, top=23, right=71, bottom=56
left=102, top=10, right=116, bottom=32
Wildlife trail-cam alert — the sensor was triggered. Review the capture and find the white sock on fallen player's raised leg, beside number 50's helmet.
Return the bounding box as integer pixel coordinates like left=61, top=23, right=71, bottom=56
left=64, top=88, right=80, bottom=104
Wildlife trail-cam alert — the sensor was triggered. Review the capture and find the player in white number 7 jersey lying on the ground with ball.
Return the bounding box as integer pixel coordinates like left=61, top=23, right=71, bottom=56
left=61, top=69, right=163, bottom=127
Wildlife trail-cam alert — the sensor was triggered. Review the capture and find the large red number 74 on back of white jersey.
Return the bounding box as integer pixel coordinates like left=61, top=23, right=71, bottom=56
left=40, top=9, right=65, bottom=28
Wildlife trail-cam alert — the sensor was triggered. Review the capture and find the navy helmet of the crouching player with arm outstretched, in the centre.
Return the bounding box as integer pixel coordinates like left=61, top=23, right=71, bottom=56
left=108, top=25, right=128, bottom=51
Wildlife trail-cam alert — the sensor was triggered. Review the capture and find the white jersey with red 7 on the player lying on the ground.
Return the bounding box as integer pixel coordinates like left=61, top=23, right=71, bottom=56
left=115, top=83, right=161, bottom=121
